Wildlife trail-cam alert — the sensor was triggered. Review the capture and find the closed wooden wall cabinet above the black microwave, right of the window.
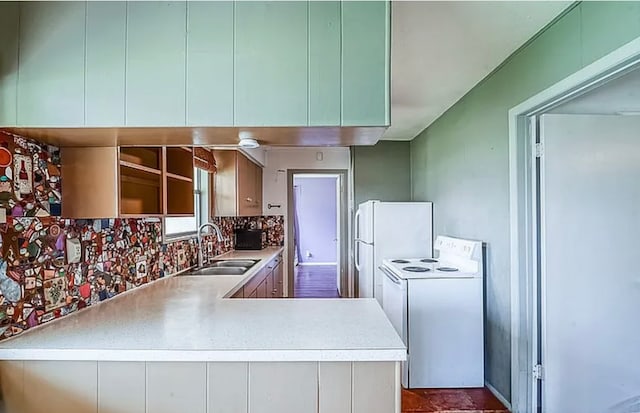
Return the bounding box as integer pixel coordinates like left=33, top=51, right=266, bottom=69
left=213, top=150, right=262, bottom=217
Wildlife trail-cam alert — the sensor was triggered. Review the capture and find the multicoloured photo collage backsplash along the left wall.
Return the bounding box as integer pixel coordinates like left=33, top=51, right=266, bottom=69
left=0, top=133, right=284, bottom=339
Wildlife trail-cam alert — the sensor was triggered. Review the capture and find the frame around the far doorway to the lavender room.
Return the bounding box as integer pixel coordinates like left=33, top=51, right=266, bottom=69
left=286, top=169, right=351, bottom=298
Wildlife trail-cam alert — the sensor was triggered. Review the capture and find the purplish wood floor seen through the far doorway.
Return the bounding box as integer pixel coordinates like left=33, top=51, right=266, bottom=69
left=294, top=265, right=340, bottom=298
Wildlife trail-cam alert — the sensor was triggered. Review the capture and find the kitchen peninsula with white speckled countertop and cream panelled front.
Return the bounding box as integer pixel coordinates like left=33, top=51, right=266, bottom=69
left=0, top=247, right=406, bottom=413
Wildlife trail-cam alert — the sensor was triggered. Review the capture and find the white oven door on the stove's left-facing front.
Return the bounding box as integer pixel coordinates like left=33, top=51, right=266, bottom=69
left=380, top=266, right=410, bottom=388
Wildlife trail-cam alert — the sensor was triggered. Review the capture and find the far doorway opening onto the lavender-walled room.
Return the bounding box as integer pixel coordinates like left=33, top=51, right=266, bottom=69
left=287, top=170, right=348, bottom=298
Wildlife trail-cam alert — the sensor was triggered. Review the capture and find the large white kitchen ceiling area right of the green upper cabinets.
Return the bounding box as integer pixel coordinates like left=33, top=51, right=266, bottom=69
left=383, top=1, right=572, bottom=140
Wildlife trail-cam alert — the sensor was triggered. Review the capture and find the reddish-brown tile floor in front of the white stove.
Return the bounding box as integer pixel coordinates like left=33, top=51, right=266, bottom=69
left=402, top=388, right=509, bottom=413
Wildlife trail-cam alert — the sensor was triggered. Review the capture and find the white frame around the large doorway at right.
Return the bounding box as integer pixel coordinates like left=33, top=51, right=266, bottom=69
left=508, top=37, right=640, bottom=413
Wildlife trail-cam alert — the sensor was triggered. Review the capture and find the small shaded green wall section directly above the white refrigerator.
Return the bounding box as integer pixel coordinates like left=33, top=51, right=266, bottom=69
left=351, top=141, right=411, bottom=205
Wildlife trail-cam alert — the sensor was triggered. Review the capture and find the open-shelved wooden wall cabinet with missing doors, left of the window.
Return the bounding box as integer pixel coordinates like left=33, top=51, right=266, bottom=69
left=61, top=147, right=194, bottom=218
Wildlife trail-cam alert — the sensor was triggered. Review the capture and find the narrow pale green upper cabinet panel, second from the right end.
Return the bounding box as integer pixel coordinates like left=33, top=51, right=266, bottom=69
left=309, top=1, right=342, bottom=126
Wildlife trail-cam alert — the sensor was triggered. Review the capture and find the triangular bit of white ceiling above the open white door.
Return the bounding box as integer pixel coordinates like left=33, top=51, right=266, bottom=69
left=549, top=69, right=640, bottom=115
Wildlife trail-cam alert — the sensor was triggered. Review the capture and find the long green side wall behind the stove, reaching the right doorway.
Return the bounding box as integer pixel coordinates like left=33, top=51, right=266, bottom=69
left=411, top=2, right=640, bottom=399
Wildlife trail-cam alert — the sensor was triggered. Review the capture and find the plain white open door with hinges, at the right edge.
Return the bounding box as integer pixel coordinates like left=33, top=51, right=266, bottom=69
left=540, top=115, right=640, bottom=413
